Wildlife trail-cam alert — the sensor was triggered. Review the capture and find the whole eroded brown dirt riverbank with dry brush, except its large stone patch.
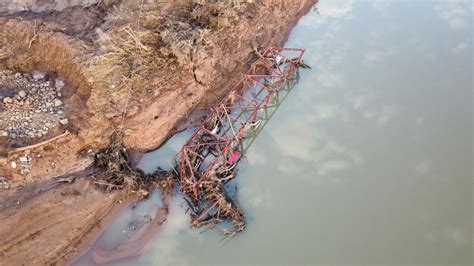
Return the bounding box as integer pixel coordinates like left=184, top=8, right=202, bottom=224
left=0, top=0, right=315, bottom=265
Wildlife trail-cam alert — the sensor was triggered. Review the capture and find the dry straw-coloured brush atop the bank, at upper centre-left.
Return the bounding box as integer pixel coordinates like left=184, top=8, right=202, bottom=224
left=87, top=0, right=255, bottom=91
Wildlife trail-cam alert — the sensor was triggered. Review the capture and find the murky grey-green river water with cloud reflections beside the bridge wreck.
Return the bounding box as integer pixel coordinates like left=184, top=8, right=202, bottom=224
left=73, top=0, right=474, bottom=265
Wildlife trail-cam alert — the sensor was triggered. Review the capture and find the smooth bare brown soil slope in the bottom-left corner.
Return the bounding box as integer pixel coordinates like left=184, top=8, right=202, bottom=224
left=0, top=179, right=126, bottom=265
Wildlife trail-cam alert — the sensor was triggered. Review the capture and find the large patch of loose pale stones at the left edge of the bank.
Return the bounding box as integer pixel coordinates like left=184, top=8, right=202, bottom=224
left=0, top=70, right=68, bottom=139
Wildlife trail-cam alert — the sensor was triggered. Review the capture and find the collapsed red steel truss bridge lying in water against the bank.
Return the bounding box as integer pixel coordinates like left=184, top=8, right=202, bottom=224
left=177, top=47, right=305, bottom=230
